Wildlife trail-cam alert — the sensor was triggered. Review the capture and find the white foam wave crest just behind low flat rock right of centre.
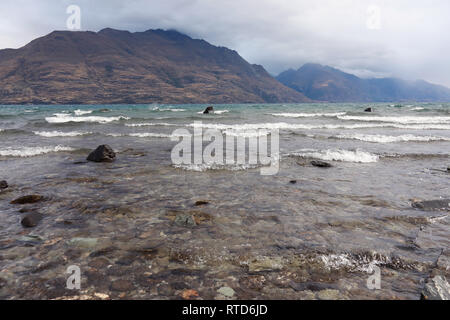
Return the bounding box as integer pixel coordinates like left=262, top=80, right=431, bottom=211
left=289, top=149, right=379, bottom=163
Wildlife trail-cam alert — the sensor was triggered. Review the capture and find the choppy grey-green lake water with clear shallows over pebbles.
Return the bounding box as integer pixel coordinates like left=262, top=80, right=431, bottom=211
left=0, top=104, right=450, bottom=299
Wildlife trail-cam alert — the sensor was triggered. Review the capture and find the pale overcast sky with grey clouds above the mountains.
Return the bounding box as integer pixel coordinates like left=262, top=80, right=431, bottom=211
left=0, top=0, right=450, bottom=87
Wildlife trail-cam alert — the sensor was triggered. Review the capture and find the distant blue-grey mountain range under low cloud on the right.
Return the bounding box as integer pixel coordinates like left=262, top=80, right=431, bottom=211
left=277, top=63, right=450, bottom=102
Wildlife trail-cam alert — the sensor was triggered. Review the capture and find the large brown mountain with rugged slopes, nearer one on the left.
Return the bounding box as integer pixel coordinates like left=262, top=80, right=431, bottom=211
left=0, top=29, right=309, bottom=104
